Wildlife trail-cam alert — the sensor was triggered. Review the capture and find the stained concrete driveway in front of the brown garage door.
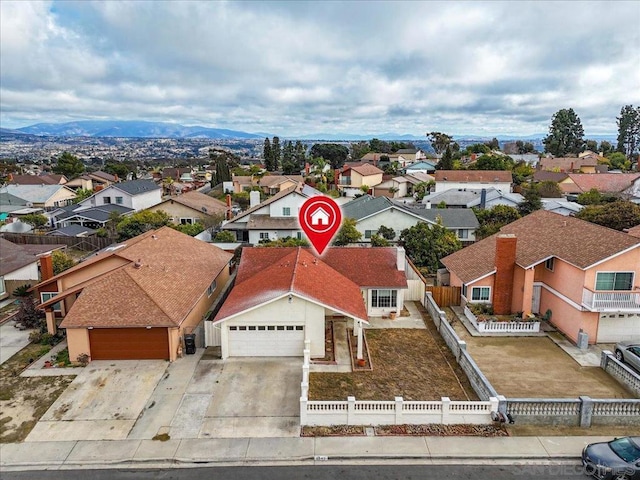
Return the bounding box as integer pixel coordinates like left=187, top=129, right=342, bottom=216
left=25, top=360, right=169, bottom=442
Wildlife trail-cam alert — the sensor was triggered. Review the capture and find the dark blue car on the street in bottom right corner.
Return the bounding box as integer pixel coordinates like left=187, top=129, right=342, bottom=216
left=582, top=437, right=640, bottom=480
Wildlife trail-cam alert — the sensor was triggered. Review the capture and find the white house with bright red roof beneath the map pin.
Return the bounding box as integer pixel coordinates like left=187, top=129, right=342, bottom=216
left=211, top=247, right=407, bottom=358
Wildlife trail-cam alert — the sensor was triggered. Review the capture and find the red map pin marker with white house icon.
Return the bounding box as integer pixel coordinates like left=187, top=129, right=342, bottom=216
left=298, top=196, right=342, bottom=255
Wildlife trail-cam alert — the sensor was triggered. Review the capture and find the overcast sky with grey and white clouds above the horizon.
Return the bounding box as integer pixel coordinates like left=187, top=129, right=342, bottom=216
left=0, top=0, right=640, bottom=137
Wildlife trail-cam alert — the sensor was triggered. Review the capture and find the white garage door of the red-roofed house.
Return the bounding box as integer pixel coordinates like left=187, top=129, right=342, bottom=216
left=228, top=325, right=304, bottom=357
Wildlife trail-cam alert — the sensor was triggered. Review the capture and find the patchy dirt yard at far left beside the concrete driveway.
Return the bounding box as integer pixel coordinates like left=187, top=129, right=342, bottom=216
left=0, top=343, right=75, bottom=443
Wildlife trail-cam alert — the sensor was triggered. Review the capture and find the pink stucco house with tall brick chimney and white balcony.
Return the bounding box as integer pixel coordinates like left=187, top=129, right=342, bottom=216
left=442, top=210, right=640, bottom=343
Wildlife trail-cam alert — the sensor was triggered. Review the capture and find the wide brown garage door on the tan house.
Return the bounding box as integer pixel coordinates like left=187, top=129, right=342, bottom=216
left=89, top=328, right=169, bottom=360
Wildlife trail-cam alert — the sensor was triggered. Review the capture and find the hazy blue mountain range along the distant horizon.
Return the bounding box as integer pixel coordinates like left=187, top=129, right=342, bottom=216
left=0, top=120, right=616, bottom=143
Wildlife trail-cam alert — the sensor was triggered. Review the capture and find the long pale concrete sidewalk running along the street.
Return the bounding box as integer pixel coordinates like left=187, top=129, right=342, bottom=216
left=0, top=436, right=611, bottom=470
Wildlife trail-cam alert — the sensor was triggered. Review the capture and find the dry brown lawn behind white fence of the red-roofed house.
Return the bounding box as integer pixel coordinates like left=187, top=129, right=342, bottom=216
left=309, top=322, right=478, bottom=400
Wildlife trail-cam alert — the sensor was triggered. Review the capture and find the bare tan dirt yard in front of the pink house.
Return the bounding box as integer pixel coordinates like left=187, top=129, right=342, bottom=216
left=445, top=309, right=635, bottom=398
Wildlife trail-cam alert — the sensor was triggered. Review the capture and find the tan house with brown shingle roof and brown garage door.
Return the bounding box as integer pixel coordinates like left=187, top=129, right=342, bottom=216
left=34, top=227, right=232, bottom=361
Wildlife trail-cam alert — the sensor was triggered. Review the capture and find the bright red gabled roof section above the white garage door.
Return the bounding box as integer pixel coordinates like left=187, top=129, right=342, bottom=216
left=214, top=248, right=367, bottom=322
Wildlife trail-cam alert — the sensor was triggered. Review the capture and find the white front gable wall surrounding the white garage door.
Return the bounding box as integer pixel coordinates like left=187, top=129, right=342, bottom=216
left=221, top=296, right=329, bottom=358
